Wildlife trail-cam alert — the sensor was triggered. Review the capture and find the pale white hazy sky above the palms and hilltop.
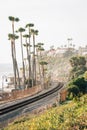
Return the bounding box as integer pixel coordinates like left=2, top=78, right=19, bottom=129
left=0, top=0, right=87, bottom=63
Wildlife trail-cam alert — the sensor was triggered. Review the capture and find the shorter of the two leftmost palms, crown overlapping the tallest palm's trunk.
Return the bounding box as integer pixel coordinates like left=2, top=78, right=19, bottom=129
left=8, top=34, right=20, bottom=89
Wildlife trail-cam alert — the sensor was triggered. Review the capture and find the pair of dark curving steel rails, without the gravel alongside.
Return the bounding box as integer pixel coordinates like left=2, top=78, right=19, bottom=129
left=0, top=83, right=63, bottom=115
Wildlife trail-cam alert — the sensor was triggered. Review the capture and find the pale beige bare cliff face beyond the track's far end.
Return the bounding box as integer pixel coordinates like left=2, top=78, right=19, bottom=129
left=46, top=55, right=71, bottom=82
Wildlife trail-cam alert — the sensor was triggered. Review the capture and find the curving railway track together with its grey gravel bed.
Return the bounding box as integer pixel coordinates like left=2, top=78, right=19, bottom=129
left=0, top=83, right=64, bottom=128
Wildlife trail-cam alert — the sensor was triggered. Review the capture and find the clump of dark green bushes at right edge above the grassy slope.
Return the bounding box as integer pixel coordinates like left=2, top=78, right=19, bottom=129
left=68, top=56, right=87, bottom=98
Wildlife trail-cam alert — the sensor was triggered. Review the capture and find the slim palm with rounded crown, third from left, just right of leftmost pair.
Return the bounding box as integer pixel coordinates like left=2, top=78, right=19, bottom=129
left=18, top=27, right=26, bottom=88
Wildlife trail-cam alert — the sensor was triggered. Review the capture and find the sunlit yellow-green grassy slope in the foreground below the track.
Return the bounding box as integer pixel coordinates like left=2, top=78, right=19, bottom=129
left=5, top=95, right=87, bottom=130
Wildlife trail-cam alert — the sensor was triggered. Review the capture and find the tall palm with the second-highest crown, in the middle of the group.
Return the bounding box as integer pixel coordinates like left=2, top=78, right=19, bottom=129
left=26, top=23, right=34, bottom=82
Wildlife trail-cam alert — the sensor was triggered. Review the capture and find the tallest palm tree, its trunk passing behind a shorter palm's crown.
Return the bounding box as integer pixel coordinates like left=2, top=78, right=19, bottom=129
left=8, top=16, right=20, bottom=86
